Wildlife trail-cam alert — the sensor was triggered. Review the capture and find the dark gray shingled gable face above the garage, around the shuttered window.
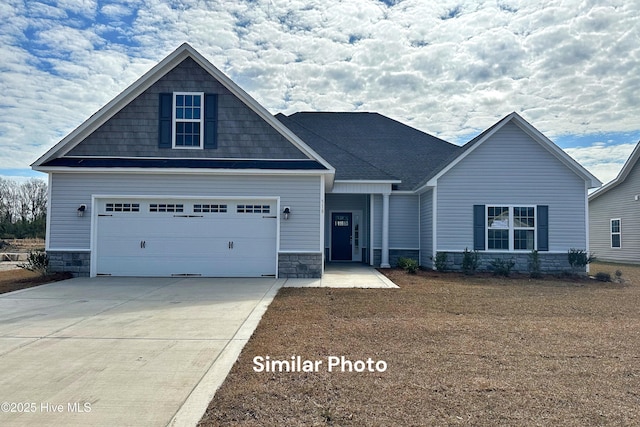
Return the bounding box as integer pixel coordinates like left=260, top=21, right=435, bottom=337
left=66, top=57, right=308, bottom=159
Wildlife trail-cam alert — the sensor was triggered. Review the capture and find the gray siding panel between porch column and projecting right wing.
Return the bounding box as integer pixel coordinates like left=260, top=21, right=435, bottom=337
left=389, top=194, right=420, bottom=249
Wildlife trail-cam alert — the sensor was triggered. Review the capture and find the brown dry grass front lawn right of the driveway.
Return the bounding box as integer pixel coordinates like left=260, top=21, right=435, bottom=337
left=201, top=264, right=640, bottom=426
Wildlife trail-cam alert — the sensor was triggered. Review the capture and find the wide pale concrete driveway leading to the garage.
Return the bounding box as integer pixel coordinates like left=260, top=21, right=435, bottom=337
left=0, top=277, right=285, bottom=426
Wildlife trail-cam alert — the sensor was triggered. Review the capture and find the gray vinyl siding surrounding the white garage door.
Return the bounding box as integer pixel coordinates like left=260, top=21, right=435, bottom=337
left=48, top=173, right=322, bottom=252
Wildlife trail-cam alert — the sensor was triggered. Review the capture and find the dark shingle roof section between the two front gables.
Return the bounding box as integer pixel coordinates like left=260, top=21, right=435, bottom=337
left=276, top=113, right=460, bottom=190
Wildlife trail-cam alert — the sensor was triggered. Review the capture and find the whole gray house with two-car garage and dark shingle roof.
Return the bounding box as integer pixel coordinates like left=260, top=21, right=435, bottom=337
left=32, top=44, right=600, bottom=277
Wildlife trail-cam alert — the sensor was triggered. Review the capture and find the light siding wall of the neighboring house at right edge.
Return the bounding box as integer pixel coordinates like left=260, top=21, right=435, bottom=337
left=589, top=163, right=640, bottom=263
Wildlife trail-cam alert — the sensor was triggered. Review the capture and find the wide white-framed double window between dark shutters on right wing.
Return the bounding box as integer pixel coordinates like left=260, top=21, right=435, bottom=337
left=487, top=206, right=536, bottom=251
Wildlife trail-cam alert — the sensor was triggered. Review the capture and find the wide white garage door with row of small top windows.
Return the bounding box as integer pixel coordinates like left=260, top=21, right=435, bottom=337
left=96, top=199, right=277, bottom=277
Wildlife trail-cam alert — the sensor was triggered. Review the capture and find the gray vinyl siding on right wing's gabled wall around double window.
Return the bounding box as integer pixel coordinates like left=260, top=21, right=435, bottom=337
left=437, top=123, right=586, bottom=252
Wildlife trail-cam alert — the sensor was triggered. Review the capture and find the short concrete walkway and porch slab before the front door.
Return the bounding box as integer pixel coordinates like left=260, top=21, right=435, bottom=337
left=283, top=263, right=398, bottom=288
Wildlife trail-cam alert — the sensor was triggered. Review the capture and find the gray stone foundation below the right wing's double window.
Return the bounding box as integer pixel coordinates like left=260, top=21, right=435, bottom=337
left=436, top=252, right=571, bottom=273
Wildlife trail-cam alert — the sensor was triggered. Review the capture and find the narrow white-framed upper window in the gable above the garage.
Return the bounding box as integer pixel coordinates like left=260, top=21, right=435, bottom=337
left=173, top=92, right=204, bottom=149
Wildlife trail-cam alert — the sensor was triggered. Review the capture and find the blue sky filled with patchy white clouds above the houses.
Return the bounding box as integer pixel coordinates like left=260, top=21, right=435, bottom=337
left=0, top=0, right=640, bottom=186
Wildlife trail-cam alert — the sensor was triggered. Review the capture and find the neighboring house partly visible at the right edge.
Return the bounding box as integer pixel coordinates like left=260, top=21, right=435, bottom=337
left=589, top=143, right=640, bottom=263
